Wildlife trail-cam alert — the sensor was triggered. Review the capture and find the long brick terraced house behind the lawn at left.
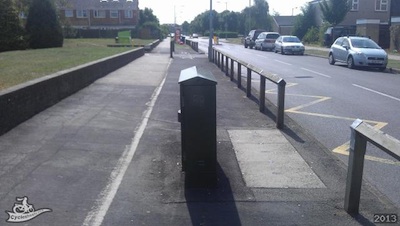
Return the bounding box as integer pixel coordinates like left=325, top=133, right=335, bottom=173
left=57, top=0, right=139, bottom=34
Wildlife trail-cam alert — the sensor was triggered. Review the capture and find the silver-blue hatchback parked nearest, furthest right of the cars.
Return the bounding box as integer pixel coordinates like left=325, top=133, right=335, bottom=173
left=329, top=36, right=388, bottom=71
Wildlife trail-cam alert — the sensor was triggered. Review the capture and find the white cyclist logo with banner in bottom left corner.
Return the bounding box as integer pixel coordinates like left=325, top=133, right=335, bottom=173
left=6, top=196, right=52, bottom=223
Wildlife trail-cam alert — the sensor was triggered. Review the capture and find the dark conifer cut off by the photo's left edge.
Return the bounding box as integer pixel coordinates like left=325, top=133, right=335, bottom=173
left=0, top=0, right=25, bottom=52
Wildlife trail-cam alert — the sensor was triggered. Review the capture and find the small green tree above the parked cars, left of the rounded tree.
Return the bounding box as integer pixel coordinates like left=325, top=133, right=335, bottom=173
left=293, top=3, right=317, bottom=39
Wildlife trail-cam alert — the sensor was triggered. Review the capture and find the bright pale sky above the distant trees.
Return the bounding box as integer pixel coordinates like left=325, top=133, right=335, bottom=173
left=139, top=0, right=311, bottom=24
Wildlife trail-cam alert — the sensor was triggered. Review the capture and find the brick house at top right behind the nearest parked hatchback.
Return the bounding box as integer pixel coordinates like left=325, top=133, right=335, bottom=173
left=310, top=0, right=400, bottom=48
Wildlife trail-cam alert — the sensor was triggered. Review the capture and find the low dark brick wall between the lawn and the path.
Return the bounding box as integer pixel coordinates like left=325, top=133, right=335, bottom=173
left=0, top=48, right=145, bottom=135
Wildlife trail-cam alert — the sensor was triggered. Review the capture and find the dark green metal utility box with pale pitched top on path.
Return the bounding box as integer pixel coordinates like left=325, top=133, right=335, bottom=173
left=178, top=67, right=217, bottom=187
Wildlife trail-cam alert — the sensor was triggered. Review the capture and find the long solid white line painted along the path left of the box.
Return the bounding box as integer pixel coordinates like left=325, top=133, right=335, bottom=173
left=82, top=61, right=171, bottom=226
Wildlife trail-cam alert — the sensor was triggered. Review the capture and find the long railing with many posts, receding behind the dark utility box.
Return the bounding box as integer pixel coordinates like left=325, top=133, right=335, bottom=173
left=212, top=48, right=286, bottom=129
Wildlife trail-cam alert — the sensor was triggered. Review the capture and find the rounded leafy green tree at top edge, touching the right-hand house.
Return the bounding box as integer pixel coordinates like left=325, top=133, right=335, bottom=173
left=319, top=0, right=351, bottom=26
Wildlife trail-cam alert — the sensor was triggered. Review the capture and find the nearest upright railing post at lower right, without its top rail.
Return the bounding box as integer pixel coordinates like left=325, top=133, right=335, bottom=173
left=344, top=119, right=367, bottom=214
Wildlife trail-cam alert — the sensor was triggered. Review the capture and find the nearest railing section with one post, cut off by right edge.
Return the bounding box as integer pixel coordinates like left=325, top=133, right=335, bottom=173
left=344, top=119, right=400, bottom=214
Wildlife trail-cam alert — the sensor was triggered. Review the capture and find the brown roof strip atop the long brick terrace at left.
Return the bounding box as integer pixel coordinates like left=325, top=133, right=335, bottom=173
left=58, top=0, right=139, bottom=9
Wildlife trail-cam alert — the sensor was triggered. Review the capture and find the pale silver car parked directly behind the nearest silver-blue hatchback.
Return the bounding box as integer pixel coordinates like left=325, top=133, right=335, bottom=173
left=274, top=35, right=305, bottom=55
